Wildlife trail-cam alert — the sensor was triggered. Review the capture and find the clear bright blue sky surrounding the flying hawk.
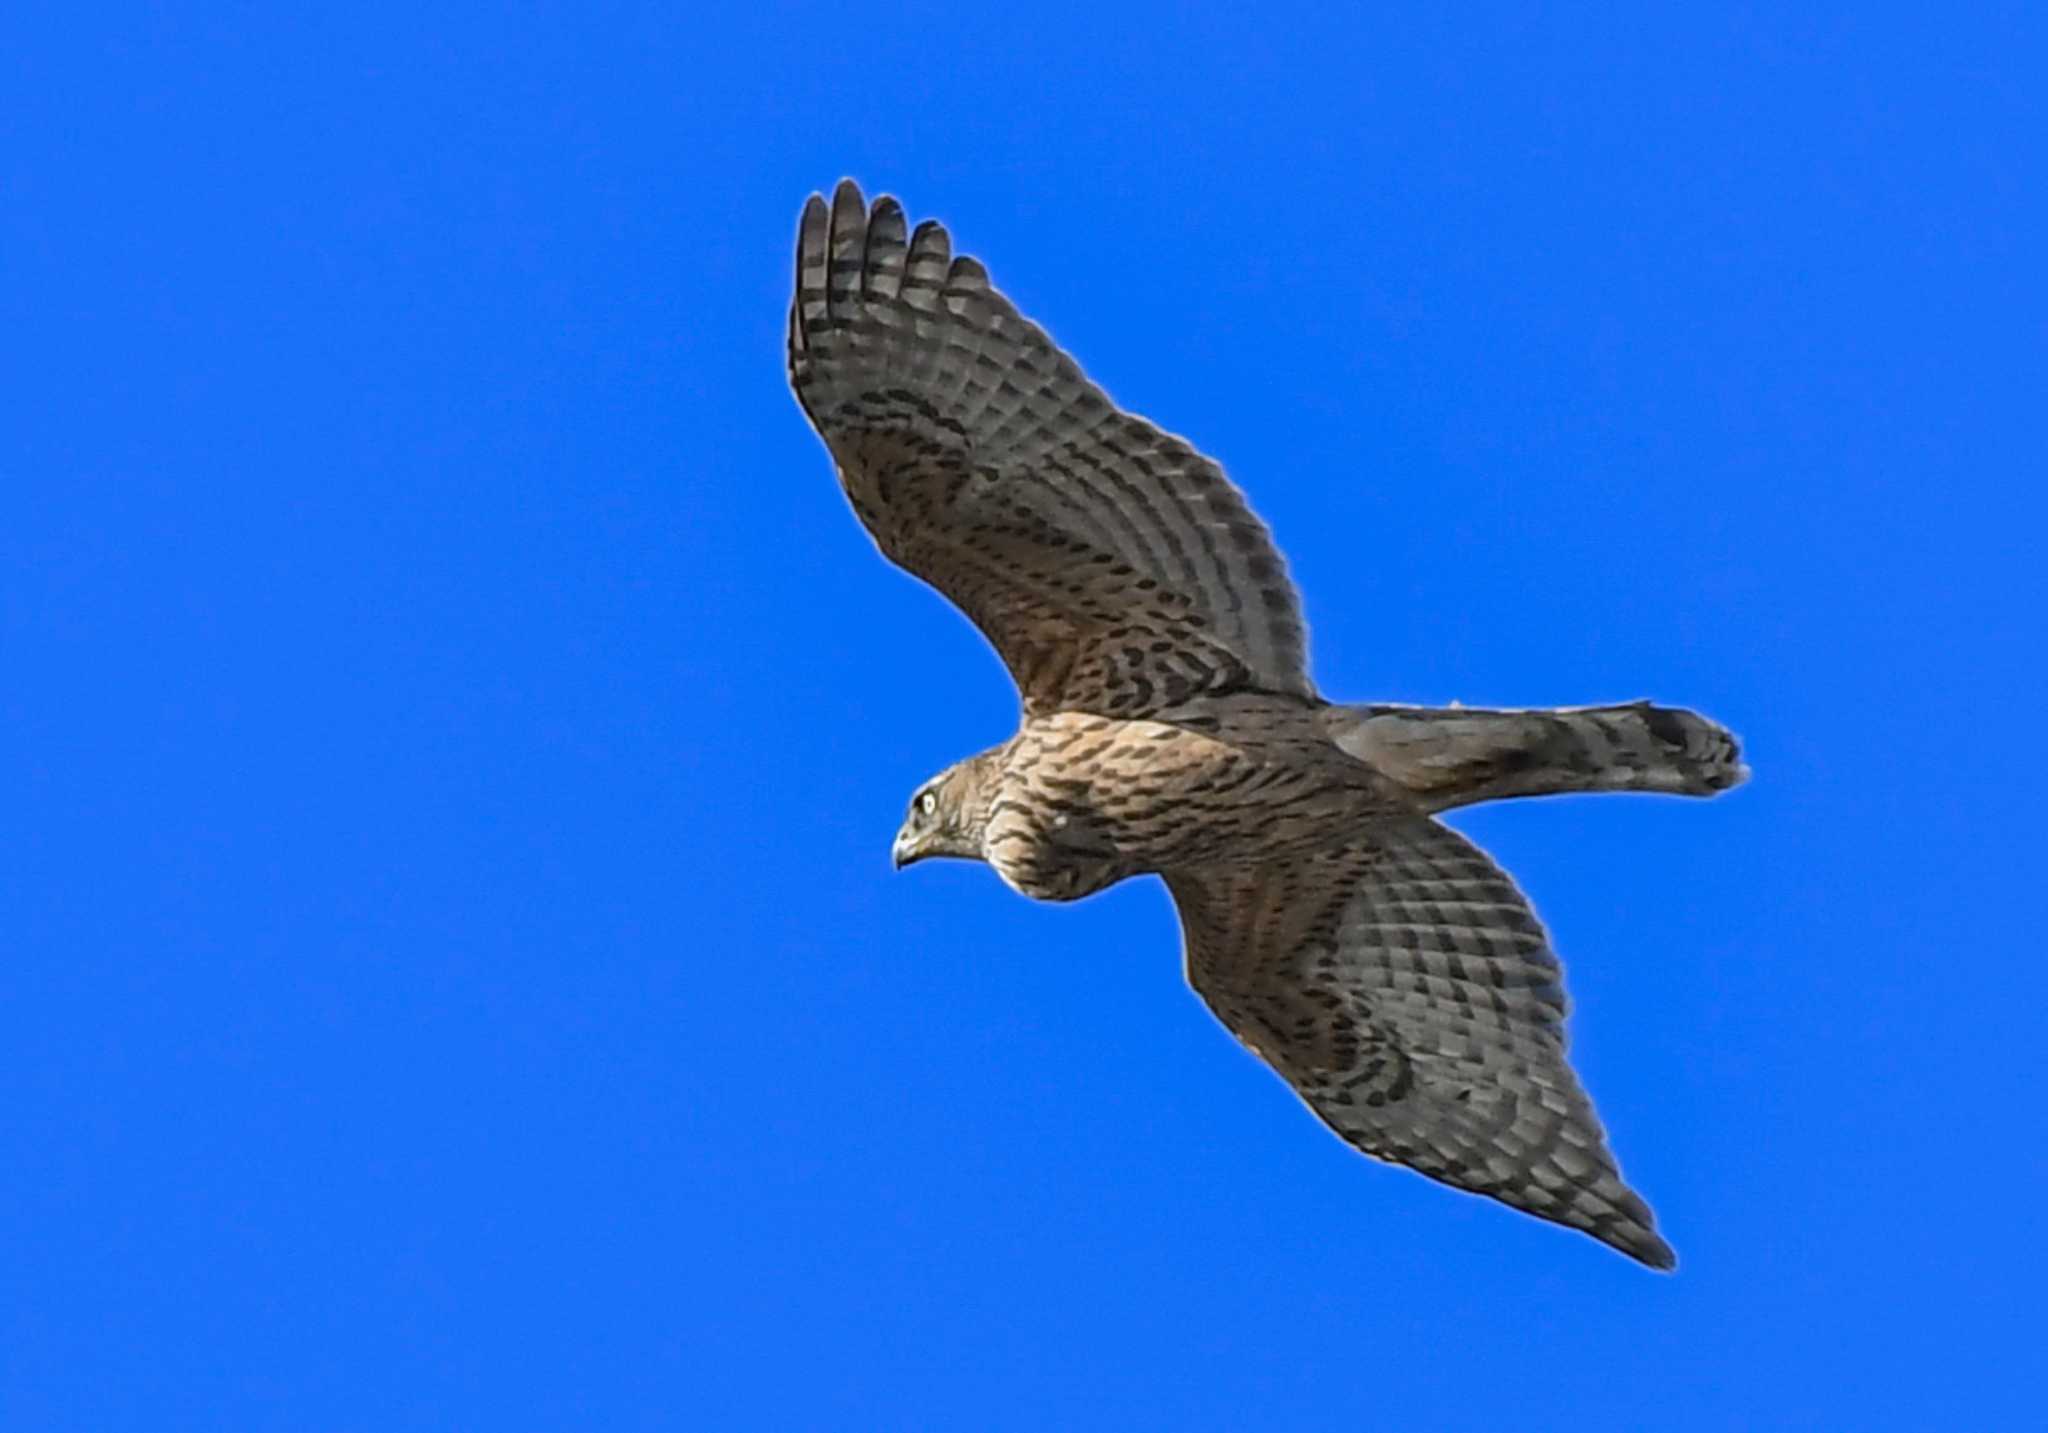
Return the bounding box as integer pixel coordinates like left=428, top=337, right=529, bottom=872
left=0, top=4, right=2048, bottom=1431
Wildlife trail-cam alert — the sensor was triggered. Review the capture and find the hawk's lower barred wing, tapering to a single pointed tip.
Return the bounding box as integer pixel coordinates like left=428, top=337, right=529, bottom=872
left=1167, top=817, right=1675, bottom=1269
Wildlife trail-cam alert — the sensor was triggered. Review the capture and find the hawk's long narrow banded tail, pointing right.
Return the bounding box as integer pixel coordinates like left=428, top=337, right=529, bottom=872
left=1323, top=702, right=1749, bottom=811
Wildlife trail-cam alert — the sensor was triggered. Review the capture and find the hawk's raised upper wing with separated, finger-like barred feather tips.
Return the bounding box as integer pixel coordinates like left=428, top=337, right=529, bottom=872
left=788, top=180, right=1313, bottom=717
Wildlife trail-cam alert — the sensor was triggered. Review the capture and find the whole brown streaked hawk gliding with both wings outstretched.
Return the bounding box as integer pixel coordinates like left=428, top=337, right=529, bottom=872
left=788, top=182, right=1747, bottom=1269
